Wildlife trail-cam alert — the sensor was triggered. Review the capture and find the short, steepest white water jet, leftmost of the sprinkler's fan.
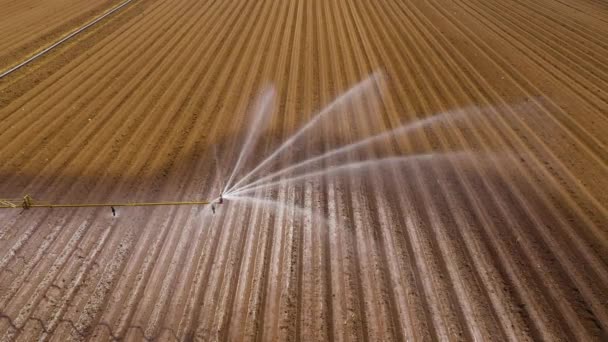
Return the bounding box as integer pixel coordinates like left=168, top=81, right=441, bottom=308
left=222, top=86, right=275, bottom=192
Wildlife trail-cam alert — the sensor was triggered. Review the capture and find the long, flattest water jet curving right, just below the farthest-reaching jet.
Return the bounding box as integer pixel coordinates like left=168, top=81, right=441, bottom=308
left=230, top=152, right=472, bottom=196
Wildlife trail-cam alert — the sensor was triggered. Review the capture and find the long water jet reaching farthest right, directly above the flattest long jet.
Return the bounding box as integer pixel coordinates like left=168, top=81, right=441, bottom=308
left=234, top=109, right=467, bottom=191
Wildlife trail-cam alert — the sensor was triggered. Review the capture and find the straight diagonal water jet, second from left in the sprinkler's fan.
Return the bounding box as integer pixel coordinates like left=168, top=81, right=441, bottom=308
left=226, top=71, right=382, bottom=192
